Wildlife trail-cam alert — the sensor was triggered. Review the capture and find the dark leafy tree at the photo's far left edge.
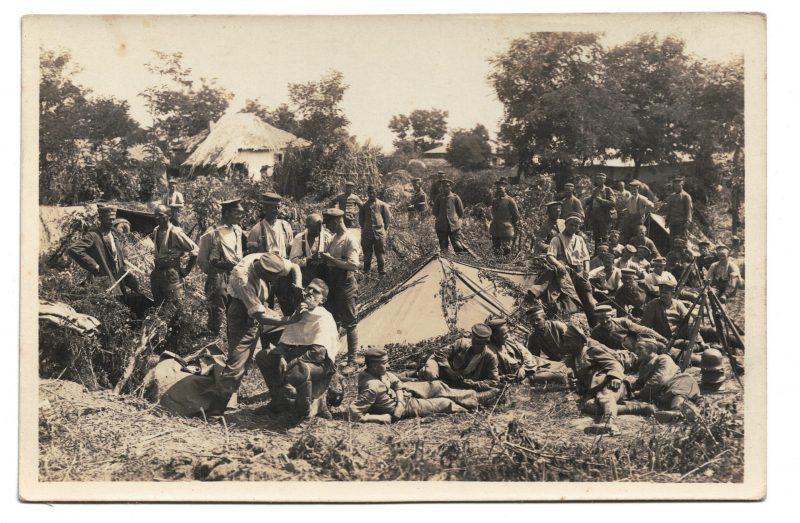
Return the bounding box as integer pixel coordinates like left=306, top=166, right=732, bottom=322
left=39, top=49, right=142, bottom=204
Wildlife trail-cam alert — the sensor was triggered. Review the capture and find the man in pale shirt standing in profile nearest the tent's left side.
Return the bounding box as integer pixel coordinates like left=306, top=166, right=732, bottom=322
left=320, top=209, right=361, bottom=371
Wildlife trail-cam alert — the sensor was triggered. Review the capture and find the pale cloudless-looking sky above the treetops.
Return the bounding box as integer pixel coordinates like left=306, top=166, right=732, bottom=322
left=31, top=14, right=745, bottom=149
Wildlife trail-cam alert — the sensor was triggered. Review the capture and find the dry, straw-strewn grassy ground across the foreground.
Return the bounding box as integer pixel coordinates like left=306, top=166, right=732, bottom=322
left=39, top=171, right=744, bottom=482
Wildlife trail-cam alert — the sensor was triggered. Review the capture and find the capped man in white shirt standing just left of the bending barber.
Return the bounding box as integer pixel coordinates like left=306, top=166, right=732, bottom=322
left=197, top=199, right=246, bottom=336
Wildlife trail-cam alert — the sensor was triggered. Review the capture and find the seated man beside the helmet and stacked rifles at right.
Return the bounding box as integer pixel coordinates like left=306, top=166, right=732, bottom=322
left=629, top=341, right=700, bottom=421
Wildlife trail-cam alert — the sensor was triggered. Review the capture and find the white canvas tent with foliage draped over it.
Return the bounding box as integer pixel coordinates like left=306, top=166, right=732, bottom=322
left=358, top=257, right=534, bottom=347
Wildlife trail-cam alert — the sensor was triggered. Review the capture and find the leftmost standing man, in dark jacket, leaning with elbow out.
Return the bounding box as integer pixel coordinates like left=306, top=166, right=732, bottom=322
left=67, top=207, right=139, bottom=299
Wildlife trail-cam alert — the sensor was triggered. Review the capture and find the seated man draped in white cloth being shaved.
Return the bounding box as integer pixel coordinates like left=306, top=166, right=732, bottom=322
left=255, top=279, right=339, bottom=419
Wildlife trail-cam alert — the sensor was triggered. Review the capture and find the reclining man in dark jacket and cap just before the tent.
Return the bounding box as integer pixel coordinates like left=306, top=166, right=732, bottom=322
left=417, top=323, right=500, bottom=391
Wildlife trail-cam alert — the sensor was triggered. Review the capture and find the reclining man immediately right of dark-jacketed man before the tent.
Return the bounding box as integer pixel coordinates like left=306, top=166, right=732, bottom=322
left=486, top=318, right=567, bottom=386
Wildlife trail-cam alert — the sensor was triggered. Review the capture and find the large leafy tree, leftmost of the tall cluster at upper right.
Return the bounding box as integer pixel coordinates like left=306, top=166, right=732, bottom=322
left=489, top=33, right=621, bottom=187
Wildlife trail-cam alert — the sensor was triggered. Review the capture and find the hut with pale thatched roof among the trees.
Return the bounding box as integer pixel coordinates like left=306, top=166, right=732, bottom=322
left=183, top=113, right=310, bottom=178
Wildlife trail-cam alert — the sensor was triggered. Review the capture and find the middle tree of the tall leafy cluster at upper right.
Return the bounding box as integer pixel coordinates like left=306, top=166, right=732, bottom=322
left=603, top=34, right=694, bottom=178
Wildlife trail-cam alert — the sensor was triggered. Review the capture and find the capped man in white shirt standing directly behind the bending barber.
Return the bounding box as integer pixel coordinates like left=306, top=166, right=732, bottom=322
left=247, top=192, right=302, bottom=316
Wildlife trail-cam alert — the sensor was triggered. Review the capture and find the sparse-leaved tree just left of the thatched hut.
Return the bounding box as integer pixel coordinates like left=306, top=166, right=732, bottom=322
left=139, top=51, right=233, bottom=145
